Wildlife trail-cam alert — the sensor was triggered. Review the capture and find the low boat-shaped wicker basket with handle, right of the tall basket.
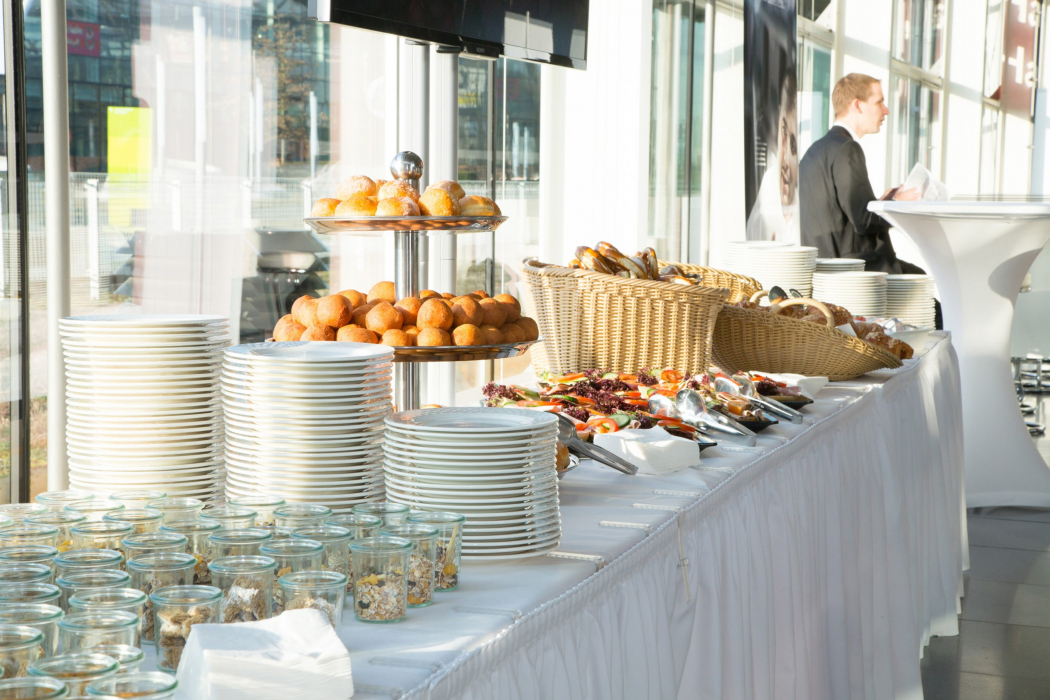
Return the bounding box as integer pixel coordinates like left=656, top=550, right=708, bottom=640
left=712, top=299, right=902, bottom=382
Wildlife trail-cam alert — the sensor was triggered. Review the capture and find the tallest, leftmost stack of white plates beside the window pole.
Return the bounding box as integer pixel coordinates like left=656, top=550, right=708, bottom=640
left=60, top=315, right=230, bottom=500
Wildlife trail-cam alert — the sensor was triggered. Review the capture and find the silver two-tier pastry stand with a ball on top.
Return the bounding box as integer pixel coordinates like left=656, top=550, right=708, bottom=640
left=303, top=151, right=540, bottom=410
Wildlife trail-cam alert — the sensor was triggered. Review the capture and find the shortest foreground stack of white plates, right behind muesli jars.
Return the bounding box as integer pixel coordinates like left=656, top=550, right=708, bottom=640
left=383, top=407, right=562, bottom=559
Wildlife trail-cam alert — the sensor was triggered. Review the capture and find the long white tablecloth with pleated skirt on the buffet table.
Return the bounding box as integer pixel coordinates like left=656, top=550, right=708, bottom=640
left=327, top=334, right=968, bottom=700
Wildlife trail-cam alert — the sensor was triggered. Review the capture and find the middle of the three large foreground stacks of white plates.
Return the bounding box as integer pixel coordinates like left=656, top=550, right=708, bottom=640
left=223, top=342, right=394, bottom=512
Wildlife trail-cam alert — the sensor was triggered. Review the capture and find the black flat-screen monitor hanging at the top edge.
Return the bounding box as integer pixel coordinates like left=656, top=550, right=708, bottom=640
left=309, top=0, right=589, bottom=68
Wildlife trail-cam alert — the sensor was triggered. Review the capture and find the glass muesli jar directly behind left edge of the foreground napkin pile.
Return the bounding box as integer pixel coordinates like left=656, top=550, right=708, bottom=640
left=149, top=586, right=223, bottom=672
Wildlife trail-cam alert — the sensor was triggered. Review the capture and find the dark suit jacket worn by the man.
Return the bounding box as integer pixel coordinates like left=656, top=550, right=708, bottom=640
left=799, top=126, right=902, bottom=274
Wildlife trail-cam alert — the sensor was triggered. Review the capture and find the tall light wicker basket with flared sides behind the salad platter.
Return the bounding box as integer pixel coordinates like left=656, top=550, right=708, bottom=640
left=522, top=260, right=730, bottom=374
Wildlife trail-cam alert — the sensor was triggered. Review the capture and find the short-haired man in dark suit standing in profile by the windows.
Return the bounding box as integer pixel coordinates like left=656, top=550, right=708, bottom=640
left=799, top=73, right=924, bottom=274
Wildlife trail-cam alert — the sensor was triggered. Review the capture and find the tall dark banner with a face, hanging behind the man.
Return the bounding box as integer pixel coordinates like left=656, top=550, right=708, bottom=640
left=743, top=0, right=799, bottom=242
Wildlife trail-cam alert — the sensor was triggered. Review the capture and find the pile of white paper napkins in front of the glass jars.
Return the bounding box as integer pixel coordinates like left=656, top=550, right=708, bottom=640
left=175, top=610, right=354, bottom=700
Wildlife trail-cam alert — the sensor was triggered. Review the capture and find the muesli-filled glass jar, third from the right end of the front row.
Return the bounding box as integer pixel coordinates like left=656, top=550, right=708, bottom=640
left=350, top=536, right=413, bottom=622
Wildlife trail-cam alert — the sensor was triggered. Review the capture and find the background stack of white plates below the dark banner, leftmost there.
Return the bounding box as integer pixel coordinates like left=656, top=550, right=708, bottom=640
left=723, top=240, right=817, bottom=297
